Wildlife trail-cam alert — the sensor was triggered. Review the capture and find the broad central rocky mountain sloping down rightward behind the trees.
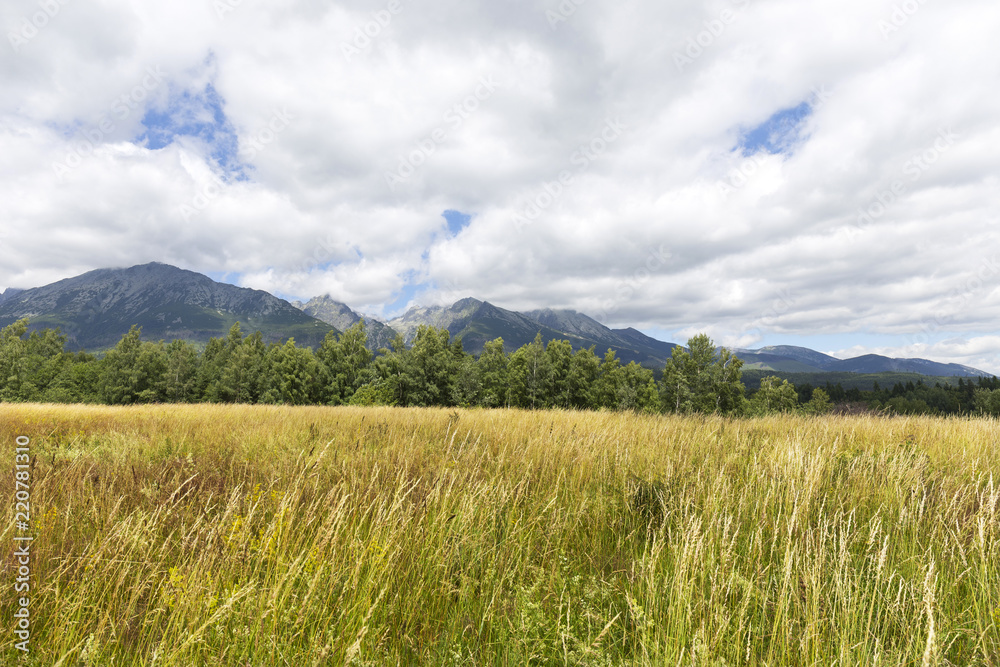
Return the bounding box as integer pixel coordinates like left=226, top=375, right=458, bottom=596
left=389, top=298, right=675, bottom=366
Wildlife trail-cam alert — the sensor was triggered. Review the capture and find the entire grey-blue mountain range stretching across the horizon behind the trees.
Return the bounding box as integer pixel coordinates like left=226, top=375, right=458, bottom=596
left=0, top=262, right=990, bottom=377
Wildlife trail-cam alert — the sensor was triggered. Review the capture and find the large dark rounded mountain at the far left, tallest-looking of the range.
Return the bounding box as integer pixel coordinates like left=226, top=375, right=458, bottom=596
left=0, top=262, right=333, bottom=350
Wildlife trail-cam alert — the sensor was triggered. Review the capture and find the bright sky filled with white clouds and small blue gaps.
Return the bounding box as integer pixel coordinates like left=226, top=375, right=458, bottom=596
left=0, top=0, right=1000, bottom=373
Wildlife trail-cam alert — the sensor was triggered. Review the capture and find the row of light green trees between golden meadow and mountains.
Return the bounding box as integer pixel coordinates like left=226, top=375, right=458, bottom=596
left=0, top=319, right=1000, bottom=415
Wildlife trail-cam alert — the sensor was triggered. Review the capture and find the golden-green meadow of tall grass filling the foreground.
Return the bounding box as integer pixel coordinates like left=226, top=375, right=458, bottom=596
left=0, top=405, right=1000, bottom=667
